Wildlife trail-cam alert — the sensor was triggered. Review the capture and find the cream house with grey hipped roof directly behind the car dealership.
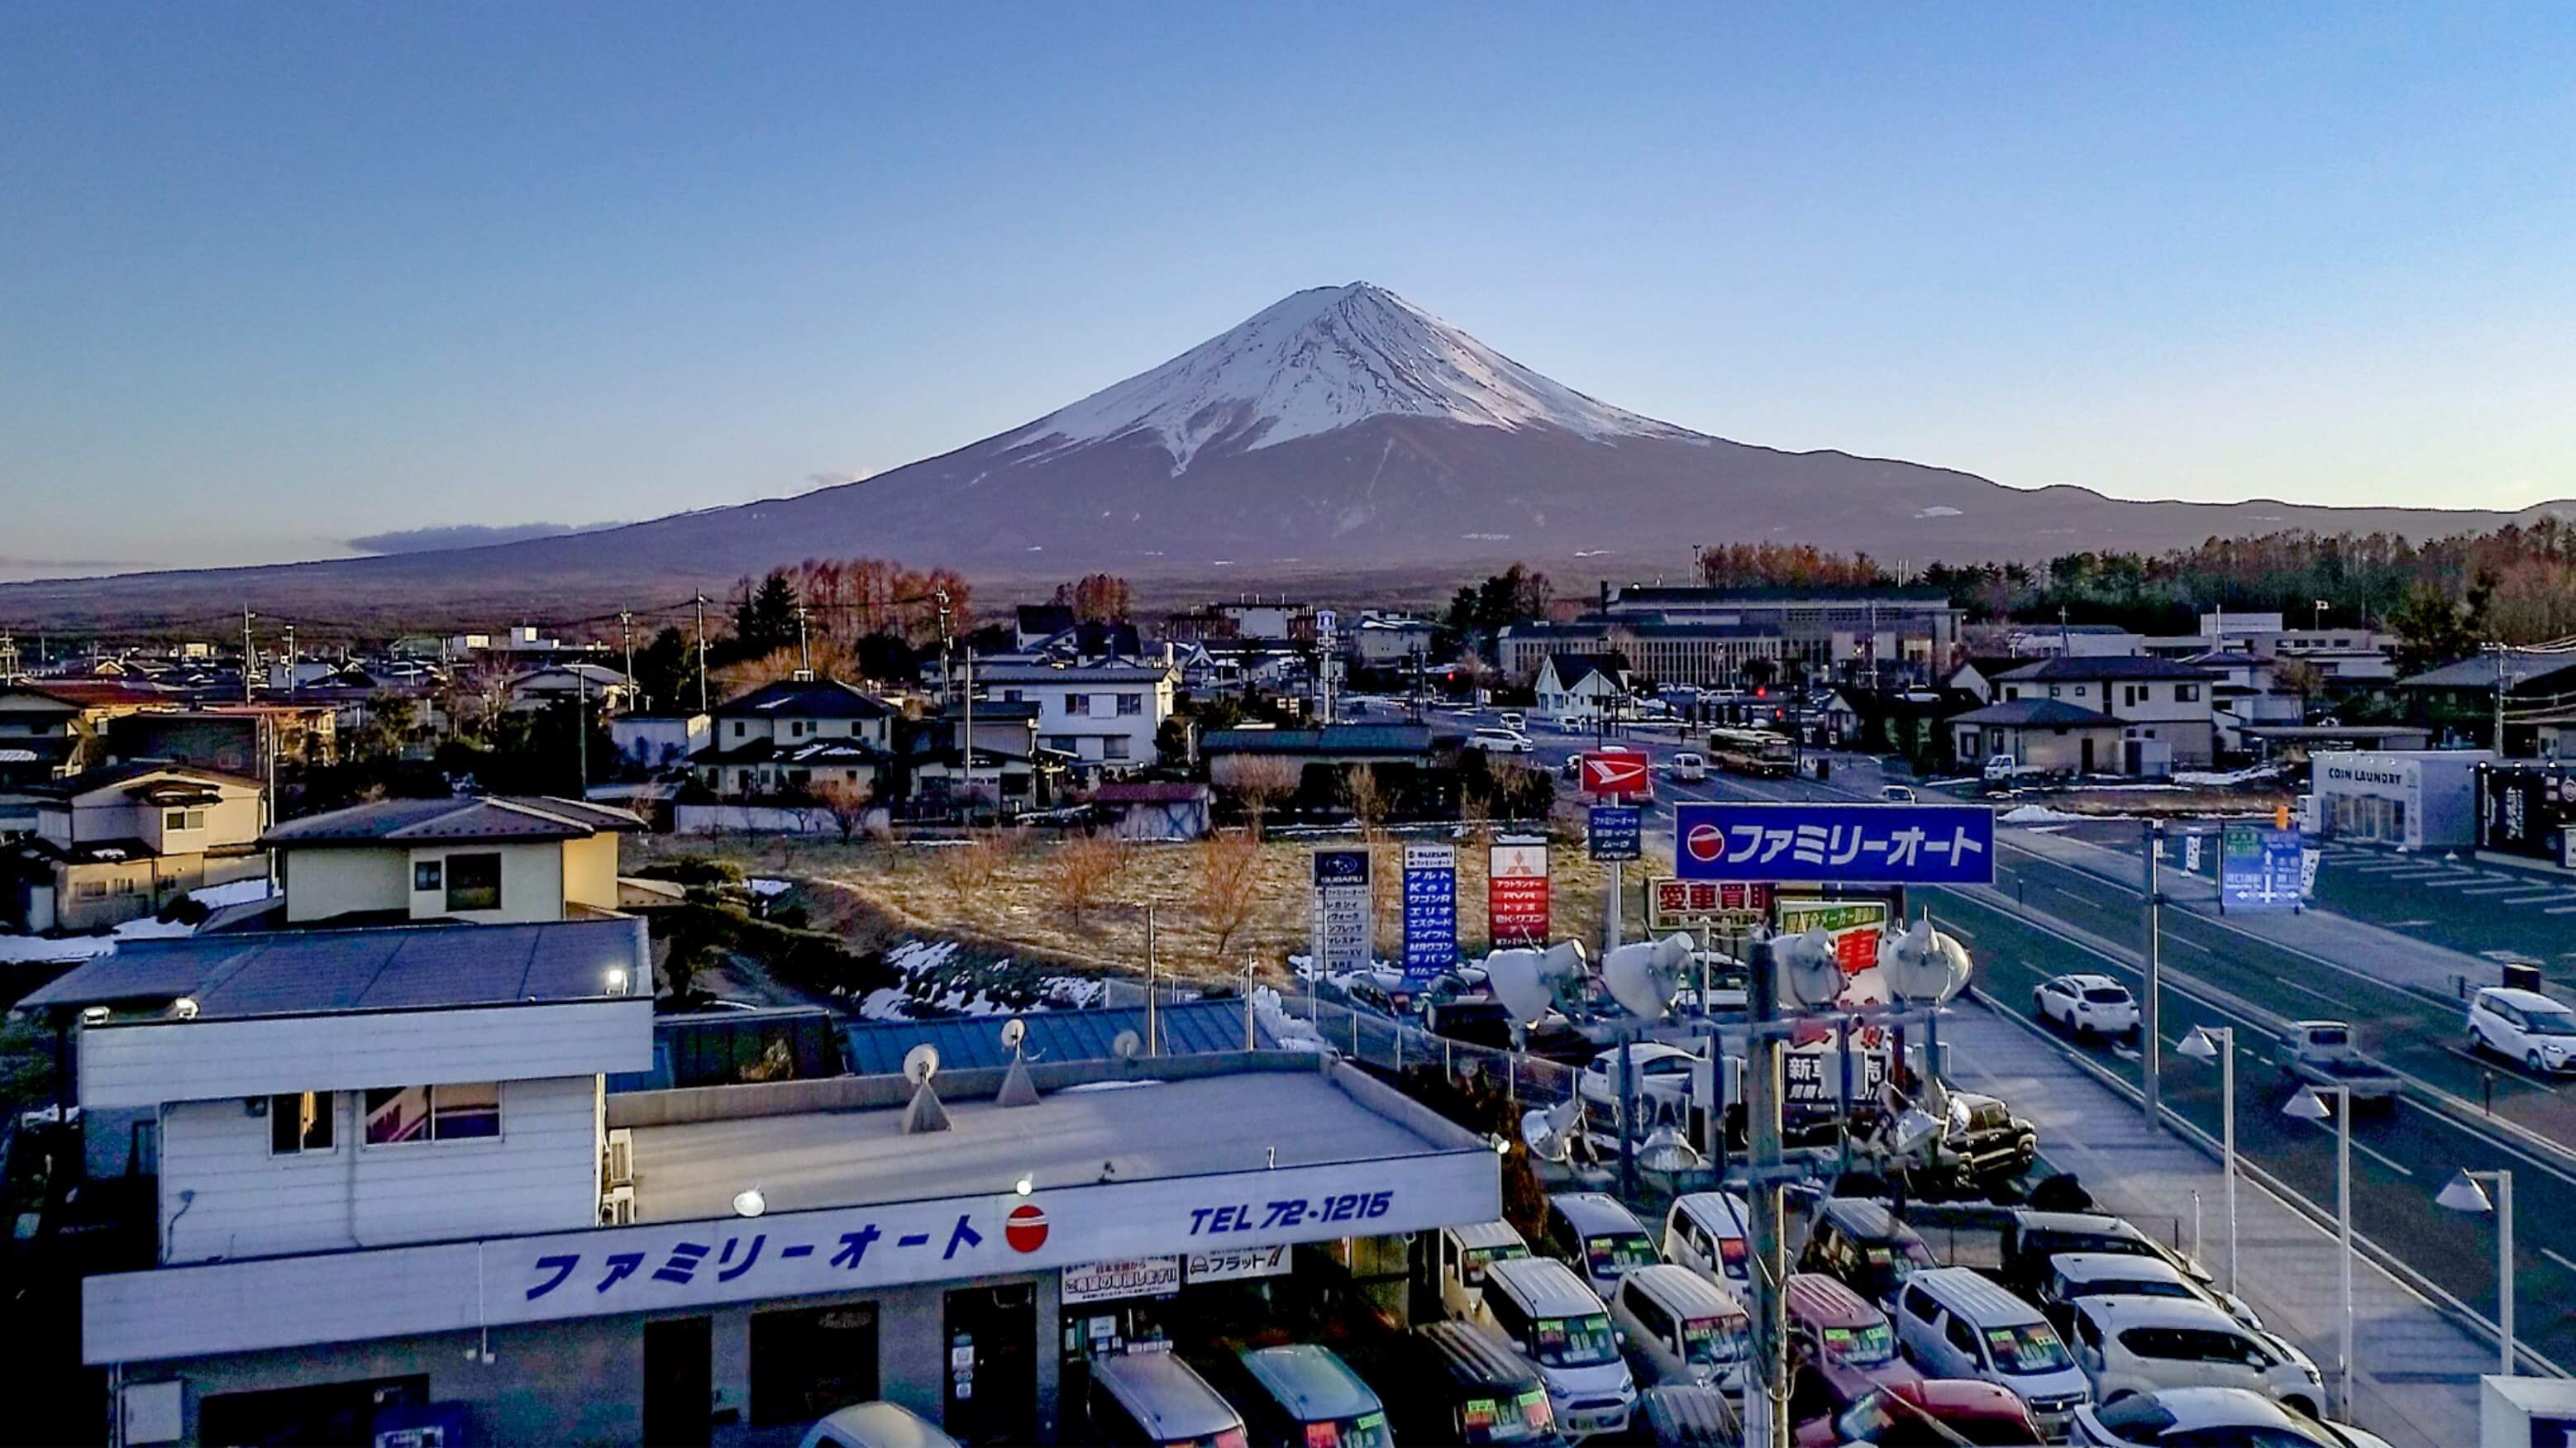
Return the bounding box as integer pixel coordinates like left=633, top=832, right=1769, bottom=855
left=263, top=793, right=644, bottom=925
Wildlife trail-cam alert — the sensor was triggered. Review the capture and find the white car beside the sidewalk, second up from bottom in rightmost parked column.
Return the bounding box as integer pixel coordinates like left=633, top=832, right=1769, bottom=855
left=2068, top=1296, right=2326, bottom=1417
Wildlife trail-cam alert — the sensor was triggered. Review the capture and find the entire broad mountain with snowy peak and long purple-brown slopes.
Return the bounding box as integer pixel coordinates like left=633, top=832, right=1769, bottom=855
left=0, top=283, right=2576, bottom=621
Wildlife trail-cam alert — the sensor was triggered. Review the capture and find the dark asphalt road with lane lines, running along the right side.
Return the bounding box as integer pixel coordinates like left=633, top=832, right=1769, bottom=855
left=1461, top=717, right=2576, bottom=1365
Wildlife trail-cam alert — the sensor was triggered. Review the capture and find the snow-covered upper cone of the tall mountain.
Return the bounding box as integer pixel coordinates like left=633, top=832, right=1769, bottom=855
left=1013, top=281, right=1695, bottom=464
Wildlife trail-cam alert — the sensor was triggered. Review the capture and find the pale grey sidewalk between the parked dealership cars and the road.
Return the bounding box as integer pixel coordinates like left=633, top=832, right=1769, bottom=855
left=1942, top=1003, right=2496, bottom=1448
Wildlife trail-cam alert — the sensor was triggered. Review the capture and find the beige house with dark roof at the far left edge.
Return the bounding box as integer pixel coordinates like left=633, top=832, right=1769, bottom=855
left=0, top=760, right=268, bottom=930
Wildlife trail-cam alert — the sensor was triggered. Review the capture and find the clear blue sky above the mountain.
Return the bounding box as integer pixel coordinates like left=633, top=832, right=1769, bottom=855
left=0, top=2, right=2576, bottom=577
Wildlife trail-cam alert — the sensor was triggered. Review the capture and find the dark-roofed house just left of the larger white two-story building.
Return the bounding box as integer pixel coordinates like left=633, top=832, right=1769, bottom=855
left=690, top=678, right=896, bottom=798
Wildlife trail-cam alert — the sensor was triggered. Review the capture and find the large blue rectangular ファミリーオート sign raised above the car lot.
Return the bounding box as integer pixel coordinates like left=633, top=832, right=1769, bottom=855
left=1672, top=802, right=1994, bottom=884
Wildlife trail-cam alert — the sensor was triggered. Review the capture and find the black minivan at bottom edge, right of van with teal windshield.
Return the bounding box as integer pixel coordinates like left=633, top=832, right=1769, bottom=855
left=1352, top=1322, right=1563, bottom=1448
